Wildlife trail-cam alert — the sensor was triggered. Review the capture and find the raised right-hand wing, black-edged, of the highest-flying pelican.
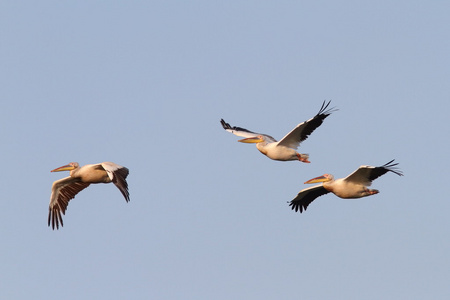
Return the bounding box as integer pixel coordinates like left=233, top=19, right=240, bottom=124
left=278, top=101, right=335, bottom=149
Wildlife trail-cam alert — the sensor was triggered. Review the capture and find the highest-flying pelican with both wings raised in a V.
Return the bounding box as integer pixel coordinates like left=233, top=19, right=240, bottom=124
left=220, top=101, right=335, bottom=163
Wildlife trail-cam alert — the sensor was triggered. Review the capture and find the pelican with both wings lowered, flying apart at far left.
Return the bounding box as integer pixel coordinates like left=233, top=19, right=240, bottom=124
left=48, top=162, right=130, bottom=229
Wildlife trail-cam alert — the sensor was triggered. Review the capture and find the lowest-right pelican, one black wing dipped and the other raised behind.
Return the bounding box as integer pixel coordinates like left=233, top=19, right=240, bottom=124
left=289, top=160, right=403, bottom=212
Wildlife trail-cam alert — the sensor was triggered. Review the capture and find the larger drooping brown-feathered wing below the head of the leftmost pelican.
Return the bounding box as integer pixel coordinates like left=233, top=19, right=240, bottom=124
left=48, top=176, right=89, bottom=229
